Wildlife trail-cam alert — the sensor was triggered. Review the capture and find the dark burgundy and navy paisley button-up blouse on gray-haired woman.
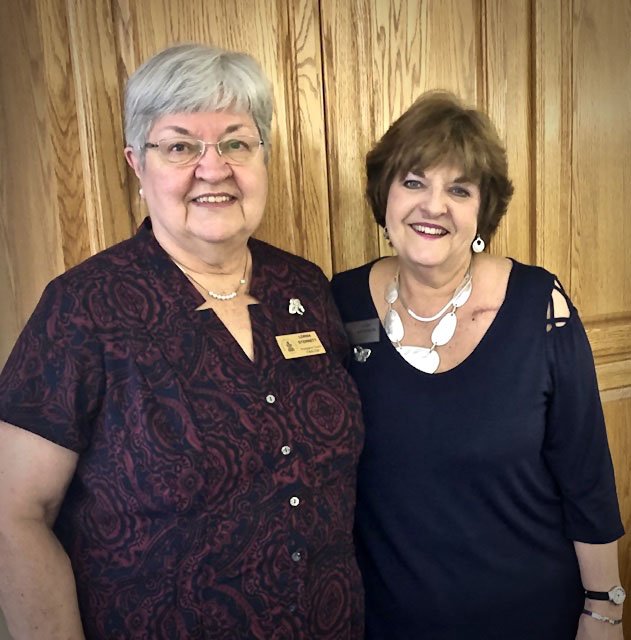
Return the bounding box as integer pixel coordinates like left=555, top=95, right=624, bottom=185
left=0, top=220, right=363, bottom=640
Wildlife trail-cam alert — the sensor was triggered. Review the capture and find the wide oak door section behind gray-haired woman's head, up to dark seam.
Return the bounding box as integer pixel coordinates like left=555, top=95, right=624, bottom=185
left=114, top=0, right=331, bottom=275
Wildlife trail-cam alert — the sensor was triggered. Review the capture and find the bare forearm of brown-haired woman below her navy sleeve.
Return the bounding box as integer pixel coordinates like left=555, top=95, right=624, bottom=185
left=574, top=542, right=624, bottom=640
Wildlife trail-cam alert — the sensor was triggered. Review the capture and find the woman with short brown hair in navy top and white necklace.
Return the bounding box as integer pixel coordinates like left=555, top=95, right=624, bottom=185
left=333, top=92, right=624, bottom=640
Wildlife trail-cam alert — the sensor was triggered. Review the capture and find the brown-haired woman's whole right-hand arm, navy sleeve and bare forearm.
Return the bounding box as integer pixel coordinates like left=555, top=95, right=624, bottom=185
left=544, top=288, right=624, bottom=640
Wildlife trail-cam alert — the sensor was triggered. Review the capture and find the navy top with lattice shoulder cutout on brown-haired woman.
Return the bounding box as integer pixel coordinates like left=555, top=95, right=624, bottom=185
left=333, top=262, right=623, bottom=640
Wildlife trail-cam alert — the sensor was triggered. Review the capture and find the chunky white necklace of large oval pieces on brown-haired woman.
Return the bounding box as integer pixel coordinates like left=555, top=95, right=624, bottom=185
left=383, top=267, right=473, bottom=373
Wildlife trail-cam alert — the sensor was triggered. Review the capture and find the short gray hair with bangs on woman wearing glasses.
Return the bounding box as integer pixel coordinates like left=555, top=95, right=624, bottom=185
left=125, top=44, right=273, bottom=162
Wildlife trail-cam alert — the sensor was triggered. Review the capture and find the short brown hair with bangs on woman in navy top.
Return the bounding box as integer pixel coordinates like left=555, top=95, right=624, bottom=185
left=366, top=91, right=513, bottom=242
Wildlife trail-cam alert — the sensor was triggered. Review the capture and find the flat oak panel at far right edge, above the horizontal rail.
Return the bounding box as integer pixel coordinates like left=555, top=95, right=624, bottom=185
left=572, top=0, right=631, bottom=318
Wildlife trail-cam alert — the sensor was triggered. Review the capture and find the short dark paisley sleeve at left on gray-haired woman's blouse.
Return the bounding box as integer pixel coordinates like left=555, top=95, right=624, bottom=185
left=0, top=278, right=104, bottom=452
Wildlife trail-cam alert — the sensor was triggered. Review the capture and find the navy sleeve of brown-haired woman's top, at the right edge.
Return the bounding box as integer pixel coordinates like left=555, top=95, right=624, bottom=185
left=544, top=300, right=624, bottom=544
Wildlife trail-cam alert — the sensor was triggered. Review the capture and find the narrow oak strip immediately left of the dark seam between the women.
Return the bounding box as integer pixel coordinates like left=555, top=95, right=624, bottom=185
left=270, top=0, right=332, bottom=276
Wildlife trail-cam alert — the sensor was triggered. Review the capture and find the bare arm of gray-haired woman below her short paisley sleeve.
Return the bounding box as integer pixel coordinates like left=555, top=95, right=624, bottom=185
left=0, top=421, right=84, bottom=640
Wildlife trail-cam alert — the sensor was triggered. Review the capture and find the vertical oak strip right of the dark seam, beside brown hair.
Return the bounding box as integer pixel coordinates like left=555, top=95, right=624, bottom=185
left=321, top=0, right=383, bottom=272
